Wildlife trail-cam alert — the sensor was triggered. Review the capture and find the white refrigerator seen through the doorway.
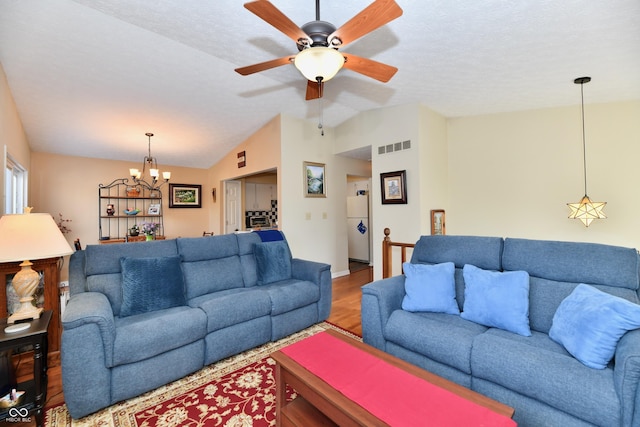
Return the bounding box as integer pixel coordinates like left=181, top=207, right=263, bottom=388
left=347, top=195, right=369, bottom=262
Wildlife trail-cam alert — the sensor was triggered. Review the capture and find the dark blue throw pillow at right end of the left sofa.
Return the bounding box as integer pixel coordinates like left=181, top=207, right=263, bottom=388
left=253, top=240, right=291, bottom=285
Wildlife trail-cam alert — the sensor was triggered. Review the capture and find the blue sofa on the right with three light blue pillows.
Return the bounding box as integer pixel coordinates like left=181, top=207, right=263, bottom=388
left=362, top=236, right=640, bottom=427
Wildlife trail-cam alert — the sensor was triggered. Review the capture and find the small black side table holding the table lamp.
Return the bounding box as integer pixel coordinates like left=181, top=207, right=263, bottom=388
left=0, top=310, right=52, bottom=426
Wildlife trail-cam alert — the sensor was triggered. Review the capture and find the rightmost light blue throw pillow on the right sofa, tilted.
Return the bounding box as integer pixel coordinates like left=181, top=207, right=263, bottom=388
left=549, top=284, right=640, bottom=369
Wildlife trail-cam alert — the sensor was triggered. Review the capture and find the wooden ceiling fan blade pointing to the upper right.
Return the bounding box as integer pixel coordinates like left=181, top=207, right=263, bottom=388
left=327, top=0, right=402, bottom=46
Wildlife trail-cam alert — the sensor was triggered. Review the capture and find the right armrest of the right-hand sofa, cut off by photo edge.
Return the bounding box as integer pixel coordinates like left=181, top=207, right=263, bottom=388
left=613, top=329, right=640, bottom=426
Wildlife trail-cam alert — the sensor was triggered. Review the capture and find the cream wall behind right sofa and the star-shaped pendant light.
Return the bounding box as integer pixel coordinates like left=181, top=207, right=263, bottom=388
left=446, top=101, right=640, bottom=247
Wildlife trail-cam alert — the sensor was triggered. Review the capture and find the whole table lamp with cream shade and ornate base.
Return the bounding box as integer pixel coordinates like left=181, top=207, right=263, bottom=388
left=0, top=208, right=73, bottom=324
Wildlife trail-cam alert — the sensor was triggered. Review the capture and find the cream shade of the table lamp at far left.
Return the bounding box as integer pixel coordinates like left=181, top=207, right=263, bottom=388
left=0, top=213, right=73, bottom=262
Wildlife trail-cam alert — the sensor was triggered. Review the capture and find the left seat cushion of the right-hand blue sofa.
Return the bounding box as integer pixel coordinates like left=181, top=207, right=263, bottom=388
left=383, top=310, right=487, bottom=374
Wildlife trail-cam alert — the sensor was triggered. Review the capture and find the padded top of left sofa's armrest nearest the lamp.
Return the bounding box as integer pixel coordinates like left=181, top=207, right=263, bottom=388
left=62, top=292, right=116, bottom=366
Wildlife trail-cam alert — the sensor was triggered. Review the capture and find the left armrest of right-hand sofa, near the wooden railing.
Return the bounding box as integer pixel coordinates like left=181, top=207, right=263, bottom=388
left=361, top=275, right=405, bottom=350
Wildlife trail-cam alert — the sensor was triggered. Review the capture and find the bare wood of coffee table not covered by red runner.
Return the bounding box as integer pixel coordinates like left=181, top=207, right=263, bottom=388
left=271, top=330, right=515, bottom=427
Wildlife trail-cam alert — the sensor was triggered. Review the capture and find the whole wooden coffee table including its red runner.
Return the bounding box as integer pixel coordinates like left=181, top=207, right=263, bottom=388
left=271, top=330, right=516, bottom=427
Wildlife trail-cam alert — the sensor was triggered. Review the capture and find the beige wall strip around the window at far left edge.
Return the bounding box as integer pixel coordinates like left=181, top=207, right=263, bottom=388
left=0, top=64, right=31, bottom=214
